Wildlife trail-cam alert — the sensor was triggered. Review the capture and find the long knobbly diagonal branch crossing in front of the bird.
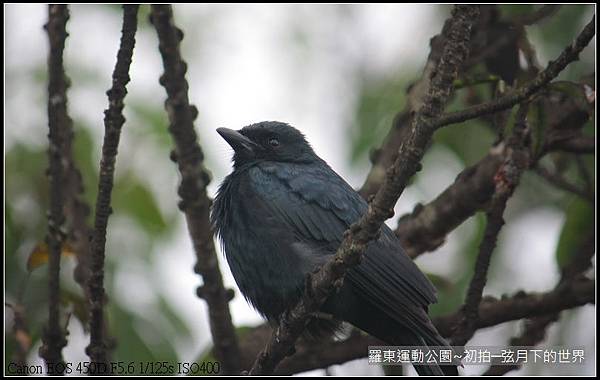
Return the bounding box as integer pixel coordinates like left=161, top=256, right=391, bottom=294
left=250, top=6, right=479, bottom=375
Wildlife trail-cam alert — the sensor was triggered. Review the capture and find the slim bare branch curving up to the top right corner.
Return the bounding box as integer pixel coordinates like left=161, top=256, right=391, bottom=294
left=434, top=16, right=596, bottom=128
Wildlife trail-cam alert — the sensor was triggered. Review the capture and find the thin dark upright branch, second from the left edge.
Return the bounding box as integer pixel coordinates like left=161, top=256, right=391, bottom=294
left=86, top=5, right=139, bottom=368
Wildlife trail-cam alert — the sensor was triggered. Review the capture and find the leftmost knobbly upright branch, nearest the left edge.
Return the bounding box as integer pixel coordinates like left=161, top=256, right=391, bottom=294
left=39, top=5, right=72, bottom=367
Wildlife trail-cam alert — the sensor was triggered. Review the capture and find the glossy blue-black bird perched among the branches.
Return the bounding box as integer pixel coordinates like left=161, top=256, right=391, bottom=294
left=210, top=121, right=458, bottom=375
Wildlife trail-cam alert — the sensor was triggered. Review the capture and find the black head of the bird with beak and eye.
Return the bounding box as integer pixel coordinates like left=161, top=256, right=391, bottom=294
left=217, top=121, right=318, bottom=167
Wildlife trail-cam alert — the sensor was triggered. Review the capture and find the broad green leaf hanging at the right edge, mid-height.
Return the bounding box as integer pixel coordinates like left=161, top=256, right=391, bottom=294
left=556, top=198, right=594, bottom=269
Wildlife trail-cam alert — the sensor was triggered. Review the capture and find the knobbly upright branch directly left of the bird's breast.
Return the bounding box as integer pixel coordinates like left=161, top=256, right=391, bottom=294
left=151, top=5, right=240, bottom=374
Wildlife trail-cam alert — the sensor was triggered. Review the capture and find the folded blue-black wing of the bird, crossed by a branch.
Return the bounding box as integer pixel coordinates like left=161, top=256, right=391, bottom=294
left=246, top=162, right=436, bottom=319
